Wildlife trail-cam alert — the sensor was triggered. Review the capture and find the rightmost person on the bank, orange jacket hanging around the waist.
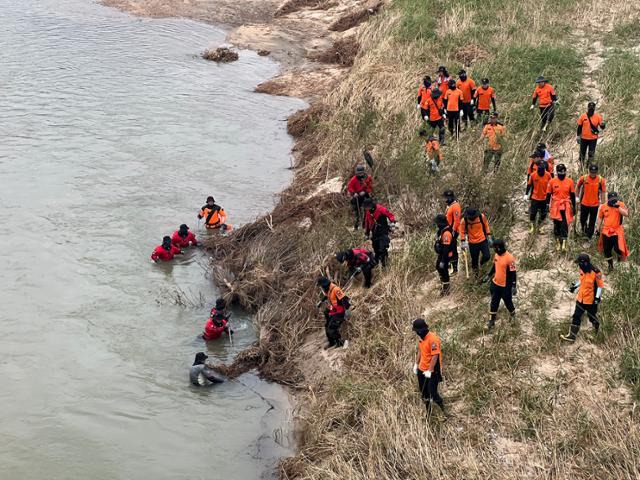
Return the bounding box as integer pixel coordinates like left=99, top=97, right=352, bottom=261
left=598, top=192, right=629, bottom=272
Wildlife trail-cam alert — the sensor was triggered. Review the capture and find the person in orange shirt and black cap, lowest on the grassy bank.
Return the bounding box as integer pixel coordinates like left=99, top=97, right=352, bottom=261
left=412, top=318, right=446, bottom=417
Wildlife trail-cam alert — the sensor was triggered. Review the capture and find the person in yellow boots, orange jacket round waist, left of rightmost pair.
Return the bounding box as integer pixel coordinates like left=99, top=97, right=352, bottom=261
left=547, top=163, right=576, bottom=252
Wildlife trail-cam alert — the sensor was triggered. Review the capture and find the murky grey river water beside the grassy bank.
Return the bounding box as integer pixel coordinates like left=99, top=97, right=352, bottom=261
left=0, top=0, right=302, bottom=480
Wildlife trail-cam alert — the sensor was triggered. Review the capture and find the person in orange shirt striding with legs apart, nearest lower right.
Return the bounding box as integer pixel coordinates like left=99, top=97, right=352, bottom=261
left=560, top=253, right=604, bottom=342
